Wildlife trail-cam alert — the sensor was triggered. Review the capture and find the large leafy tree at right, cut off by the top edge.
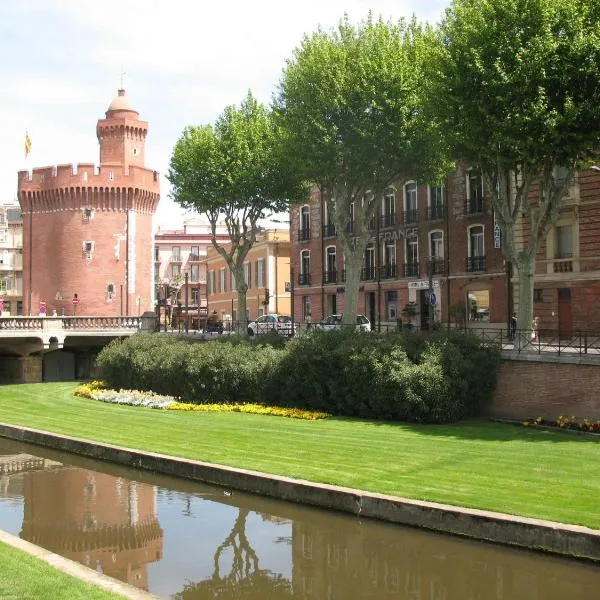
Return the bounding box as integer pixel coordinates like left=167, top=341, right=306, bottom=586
left=427, top=0, right=600, bottom=329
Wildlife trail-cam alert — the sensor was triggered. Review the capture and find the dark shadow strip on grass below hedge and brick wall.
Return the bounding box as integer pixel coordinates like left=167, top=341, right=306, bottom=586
left=328, top=416, right=600, bottom=450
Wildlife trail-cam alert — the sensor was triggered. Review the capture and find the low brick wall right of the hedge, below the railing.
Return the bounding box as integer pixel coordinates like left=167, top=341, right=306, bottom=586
left=488, top=359, right=600, bottom=420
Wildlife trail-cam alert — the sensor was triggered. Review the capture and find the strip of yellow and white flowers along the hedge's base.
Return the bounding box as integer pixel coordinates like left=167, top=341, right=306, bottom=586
left=73, top=381, right=329, bottom=421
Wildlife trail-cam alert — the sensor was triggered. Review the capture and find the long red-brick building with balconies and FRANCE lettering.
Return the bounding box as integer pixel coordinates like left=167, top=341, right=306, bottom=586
left=290, top=165, right=600, bottom=334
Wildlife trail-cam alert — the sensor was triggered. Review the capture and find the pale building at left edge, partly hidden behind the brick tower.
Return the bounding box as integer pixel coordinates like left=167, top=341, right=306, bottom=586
left=0, top=202, right=23, bottom=316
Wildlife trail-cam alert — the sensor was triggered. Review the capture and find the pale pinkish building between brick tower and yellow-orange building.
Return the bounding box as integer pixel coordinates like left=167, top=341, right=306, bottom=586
left=154, top=218, right=229, bottom=306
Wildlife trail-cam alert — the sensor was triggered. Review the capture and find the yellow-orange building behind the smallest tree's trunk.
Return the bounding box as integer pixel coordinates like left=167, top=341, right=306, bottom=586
left=206, top=229, right=292, bottom=323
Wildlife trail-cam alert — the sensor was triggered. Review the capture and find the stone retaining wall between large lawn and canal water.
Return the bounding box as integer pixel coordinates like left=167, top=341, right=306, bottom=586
left=0, top=423, right=600, bottom=560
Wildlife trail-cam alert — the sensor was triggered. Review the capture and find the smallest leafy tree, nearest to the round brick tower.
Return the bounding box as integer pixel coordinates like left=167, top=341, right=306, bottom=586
left=167, top=92, right=307, bottom=332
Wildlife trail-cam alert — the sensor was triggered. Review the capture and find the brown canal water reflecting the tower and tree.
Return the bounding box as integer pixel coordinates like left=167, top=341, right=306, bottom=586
left=0, top=438, right=600, bottom=600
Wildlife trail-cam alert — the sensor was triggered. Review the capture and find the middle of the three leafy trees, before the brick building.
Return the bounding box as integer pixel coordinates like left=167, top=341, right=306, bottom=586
left=275, top=15, right=446, bottom=326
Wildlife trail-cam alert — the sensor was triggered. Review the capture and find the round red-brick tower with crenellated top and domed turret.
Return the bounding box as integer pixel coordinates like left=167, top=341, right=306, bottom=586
left=18, top=89, right=160, bottom=316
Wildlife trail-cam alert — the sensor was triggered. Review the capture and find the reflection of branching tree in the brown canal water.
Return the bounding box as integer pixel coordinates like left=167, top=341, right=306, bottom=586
left=173, top=508, right=293, bottom=600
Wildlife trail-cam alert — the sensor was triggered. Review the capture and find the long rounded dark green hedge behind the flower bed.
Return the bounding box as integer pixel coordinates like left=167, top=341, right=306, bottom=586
left=98, top=330, right=500, bottom=423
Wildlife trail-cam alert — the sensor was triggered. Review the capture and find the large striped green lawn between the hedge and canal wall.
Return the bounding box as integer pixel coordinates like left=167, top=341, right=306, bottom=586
left=0, top=383, right=600, bottom=529
